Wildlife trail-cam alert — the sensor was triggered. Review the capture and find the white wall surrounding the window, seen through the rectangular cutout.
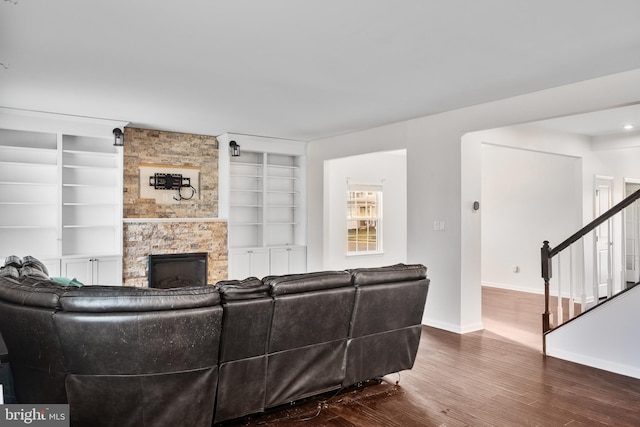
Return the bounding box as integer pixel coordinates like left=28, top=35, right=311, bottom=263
left=323, top=150, right=407, bottom=270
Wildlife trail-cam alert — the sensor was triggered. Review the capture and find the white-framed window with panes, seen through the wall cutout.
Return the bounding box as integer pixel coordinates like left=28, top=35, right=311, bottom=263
left=347, top=185, right=382, bottom=255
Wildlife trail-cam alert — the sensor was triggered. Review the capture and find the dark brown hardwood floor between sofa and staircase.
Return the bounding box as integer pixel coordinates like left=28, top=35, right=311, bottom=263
left=223, top=288, right=640, bottom=427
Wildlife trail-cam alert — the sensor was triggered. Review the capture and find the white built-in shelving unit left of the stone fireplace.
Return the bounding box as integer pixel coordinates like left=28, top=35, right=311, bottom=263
left=0, top=113, right=122, bottom=284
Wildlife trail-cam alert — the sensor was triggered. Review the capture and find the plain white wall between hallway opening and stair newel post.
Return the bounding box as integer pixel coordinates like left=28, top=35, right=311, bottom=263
left=480, top=144, right=582, bottom=293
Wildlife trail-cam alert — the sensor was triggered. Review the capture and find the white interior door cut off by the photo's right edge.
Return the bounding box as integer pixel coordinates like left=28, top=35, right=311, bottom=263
left=624, top=182, right=640, bottom=284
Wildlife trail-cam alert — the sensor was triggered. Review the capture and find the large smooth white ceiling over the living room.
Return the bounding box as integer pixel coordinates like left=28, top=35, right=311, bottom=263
left=0, top=0, right=640, bottom=140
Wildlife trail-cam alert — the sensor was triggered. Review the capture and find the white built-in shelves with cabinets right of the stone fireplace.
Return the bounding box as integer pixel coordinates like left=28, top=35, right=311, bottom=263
left=218, top=134, right=306, bottom=279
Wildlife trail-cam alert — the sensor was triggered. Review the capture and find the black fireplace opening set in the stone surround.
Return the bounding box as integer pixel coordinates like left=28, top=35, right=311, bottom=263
left=149, top=252, right=207, bottom=289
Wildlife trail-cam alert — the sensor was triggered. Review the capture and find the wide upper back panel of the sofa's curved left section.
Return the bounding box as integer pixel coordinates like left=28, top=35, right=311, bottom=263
left=53, top=306, right=222, bottom=376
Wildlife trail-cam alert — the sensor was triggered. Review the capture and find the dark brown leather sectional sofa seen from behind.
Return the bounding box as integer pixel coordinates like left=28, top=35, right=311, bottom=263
left=0, top=264, right=429, bottom=426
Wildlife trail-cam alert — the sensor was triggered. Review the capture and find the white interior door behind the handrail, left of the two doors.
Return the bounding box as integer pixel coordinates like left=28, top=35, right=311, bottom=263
left=594, top=177, right=613, bottom=298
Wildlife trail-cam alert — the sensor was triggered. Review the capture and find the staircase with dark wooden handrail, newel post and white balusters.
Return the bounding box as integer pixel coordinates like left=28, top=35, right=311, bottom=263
left=540, top=190, right=640, bottom=378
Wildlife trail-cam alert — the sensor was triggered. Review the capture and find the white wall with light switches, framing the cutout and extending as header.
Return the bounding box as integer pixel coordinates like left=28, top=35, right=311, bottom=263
left=307, top=69, right=640, bottom=332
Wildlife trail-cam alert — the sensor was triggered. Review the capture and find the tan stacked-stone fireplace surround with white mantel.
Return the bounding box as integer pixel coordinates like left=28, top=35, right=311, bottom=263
left=122, top=127, right=228, bottom=287
